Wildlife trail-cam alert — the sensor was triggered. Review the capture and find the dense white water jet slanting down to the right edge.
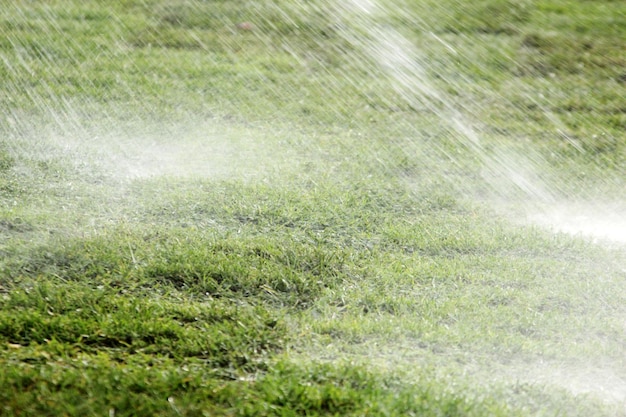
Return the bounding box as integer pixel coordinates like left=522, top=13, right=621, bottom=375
left=335, top=0, right=626, bottom=242
